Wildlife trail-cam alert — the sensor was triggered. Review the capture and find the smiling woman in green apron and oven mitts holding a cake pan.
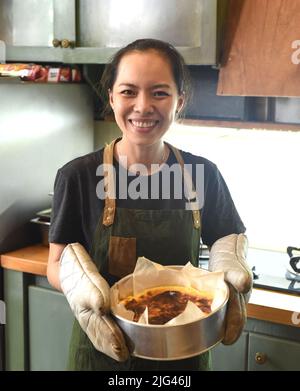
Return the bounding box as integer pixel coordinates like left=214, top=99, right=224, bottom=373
left=47, top=39, right=251, bottom=370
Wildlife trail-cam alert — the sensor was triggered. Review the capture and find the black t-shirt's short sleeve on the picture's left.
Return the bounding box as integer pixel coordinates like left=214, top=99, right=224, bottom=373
left=49, top=170, right=83, bottom=244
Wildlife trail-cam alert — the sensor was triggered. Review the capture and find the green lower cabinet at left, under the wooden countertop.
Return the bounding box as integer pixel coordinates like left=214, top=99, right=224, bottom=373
left=4, top=270, right=74, bottom=371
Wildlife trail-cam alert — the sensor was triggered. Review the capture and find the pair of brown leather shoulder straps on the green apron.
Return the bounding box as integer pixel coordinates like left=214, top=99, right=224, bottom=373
left=102, top=139, right=201, bottom=229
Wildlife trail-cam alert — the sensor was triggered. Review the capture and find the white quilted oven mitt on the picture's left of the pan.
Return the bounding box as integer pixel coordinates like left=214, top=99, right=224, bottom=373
left=59, top=243, right=129, bottom=361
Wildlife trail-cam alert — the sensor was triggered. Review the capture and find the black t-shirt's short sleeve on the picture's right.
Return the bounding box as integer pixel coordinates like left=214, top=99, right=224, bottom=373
left=202, top=165, right=246, bottom=246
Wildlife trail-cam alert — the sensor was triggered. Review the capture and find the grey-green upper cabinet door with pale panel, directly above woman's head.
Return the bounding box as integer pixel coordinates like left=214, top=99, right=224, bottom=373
left=77, top=0, right=217, bottom=65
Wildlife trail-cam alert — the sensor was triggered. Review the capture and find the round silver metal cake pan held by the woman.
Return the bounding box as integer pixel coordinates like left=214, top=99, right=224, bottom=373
left=112, top=275, right=229, bottom=361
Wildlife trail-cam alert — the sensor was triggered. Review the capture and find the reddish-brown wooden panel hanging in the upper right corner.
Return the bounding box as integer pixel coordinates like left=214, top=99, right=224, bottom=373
left=218, top=0, right=300, bottom=97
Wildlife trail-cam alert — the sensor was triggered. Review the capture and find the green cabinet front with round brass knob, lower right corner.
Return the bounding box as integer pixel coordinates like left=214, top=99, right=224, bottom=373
left=248, top=333, right=300, bottom=371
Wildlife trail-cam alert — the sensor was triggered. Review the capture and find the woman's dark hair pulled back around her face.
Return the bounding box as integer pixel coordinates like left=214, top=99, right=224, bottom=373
left=100, top=38, right=190, bottom=118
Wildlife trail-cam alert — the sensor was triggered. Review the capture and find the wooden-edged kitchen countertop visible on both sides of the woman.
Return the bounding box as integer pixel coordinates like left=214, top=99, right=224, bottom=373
left=0, top=244, right=300, bottom=327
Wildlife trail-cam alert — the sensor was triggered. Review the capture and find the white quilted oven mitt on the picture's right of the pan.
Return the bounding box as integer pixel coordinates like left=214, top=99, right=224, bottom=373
left=209, top=234, right=252, bottom=345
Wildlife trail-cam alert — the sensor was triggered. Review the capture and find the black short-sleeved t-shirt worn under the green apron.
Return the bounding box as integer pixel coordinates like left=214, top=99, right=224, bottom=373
left=49, top=145, right=245, bottom=251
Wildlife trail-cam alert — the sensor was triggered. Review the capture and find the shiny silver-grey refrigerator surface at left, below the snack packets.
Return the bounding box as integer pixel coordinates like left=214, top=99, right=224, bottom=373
left=0, top=81, right=94, bottom=253
